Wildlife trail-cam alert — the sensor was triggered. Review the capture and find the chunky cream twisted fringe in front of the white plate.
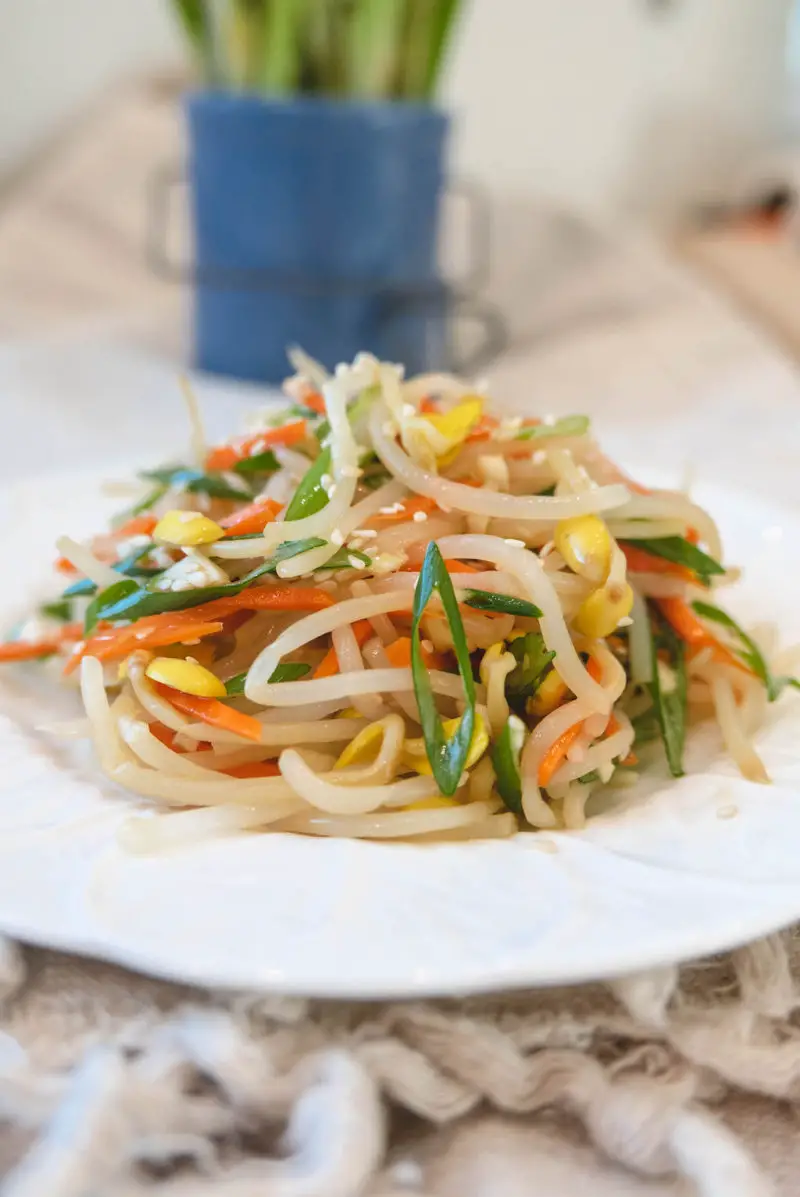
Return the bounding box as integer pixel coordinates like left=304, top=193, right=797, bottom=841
left=0, top=934, right=800, bottom=1197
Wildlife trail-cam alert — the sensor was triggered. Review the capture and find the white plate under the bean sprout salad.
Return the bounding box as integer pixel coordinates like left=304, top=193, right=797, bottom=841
left=0, top=476, right=800, bottom=997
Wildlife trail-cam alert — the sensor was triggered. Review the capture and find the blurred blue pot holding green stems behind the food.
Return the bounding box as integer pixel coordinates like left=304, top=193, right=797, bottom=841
left=188, top=93, right=448, bottom=382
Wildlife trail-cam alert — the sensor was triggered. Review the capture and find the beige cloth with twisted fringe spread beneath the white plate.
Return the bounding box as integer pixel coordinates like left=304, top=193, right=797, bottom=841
left=0, top=79, right=800, bottom=1197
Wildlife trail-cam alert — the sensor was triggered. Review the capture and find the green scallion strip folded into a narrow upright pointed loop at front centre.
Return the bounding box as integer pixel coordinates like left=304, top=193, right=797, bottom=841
left=411, top=541, right=475, bottom=797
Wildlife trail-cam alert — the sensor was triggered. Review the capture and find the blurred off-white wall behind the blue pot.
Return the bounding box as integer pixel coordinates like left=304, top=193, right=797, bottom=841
left=0, top=0, right=793, bottom=217
